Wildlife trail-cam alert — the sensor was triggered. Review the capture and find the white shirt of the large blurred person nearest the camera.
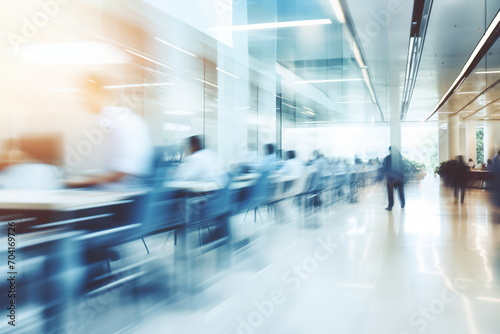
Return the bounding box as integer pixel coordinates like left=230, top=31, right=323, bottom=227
left=99, top=107, right=153, bottom=176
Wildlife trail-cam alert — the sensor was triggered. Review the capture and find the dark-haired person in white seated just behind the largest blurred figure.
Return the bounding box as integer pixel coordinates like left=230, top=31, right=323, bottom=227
left=175, top=136, right=221, bottom=182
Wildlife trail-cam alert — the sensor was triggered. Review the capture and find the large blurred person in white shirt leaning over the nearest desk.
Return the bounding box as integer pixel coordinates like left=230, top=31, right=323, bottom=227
left=67, top=75, right=153, bottom=189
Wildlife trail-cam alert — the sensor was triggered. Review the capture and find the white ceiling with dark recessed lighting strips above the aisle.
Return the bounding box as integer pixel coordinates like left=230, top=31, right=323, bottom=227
left=347, top=0, right=500, bottom=121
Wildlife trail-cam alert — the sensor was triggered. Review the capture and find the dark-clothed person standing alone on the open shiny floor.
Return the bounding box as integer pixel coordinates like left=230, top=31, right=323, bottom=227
left=382, top=146, right=406, bottom=211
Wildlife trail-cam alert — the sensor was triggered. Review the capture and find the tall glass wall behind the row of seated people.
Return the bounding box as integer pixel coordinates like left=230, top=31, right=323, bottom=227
left=0, top=0, right=388, bottom=172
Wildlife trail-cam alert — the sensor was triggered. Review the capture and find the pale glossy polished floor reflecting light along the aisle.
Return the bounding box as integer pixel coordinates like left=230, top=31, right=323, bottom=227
left=121, top=177, right=500, bottom=334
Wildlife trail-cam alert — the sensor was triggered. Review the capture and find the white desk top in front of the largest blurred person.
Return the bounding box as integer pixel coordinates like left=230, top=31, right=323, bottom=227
left=0, top=189, right=145, bottom=211
